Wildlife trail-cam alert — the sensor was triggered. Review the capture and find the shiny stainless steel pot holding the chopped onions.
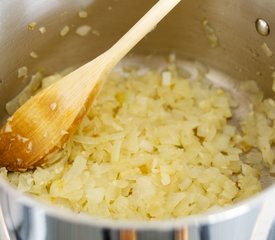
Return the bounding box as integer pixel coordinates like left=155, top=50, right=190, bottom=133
left=0, top=0, right=275, bottom=240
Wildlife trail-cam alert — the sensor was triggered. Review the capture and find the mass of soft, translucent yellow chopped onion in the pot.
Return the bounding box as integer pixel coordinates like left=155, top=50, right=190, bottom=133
left=1, top=59, right=275, bottom=220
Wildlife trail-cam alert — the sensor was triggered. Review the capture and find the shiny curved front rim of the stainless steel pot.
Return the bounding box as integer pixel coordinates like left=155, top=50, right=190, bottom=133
left=0, top=177, right=275, bottom=231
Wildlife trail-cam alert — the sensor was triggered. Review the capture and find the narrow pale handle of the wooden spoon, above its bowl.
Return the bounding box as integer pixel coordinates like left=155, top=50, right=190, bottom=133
left=106, top=0, right=181, bottom=68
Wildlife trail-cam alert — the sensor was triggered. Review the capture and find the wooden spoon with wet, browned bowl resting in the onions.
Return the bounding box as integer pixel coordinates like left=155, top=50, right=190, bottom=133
left=0, top=0, right=180, bottom=171
